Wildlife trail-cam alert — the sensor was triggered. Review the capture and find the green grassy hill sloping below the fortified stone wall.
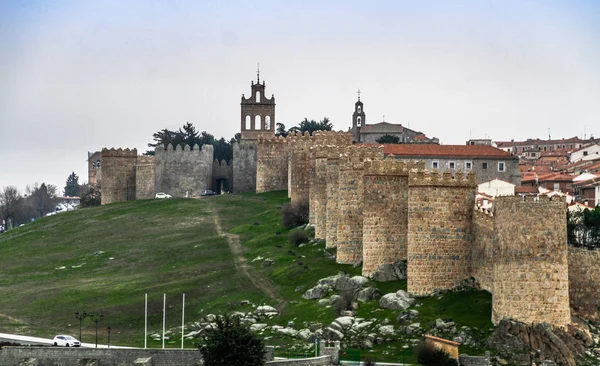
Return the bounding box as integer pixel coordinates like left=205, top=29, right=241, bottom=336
left=0, top=192, right=491, bottom=361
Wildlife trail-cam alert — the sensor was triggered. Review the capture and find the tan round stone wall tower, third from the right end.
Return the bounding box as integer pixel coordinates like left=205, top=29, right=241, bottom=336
left=362, top=157, right=422, bottom=276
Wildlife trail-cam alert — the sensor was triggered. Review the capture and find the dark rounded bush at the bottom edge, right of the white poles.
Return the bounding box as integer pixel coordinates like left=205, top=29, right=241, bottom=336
left=196, top=315, right=266, bottom=366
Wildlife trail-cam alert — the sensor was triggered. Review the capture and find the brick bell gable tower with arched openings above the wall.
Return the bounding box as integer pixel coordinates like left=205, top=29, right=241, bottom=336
left=240, top=69, right=275, bottom=140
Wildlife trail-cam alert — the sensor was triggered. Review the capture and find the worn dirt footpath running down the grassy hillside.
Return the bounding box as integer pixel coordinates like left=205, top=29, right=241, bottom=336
left=210, top=205, right=287, bottom=314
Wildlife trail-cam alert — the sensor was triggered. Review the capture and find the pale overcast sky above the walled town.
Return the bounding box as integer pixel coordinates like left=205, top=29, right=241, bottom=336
left=0, top=0, right=600, bottom=191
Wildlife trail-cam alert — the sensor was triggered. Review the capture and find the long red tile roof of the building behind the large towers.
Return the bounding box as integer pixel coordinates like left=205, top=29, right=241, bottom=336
left=374, top=144, right=518, bottom=159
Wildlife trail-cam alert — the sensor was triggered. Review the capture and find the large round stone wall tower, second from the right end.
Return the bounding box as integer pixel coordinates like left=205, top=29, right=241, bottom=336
left=408, top=171, right=475, bottom=295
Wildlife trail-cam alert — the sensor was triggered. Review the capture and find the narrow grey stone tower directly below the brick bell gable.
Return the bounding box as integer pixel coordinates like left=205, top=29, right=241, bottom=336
left=232, top=141, right=258, bottom=193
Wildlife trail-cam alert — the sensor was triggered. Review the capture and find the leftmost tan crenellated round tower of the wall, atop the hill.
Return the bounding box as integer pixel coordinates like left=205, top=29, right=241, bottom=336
left=102, top=148, right=137, bottom=205
